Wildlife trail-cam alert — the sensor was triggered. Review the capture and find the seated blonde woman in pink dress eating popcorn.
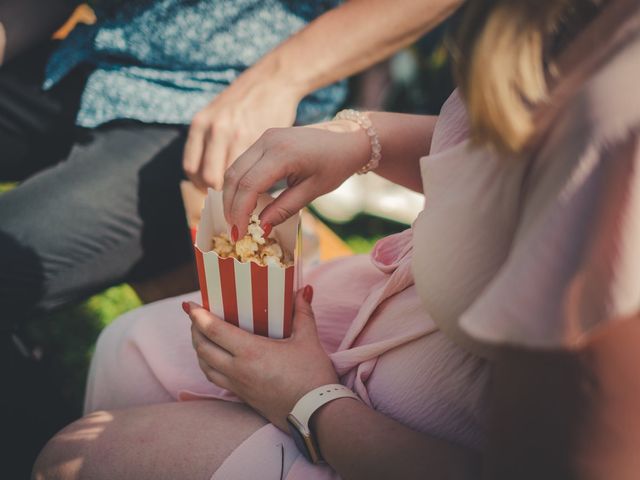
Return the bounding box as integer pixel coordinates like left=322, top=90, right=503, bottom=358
left=34, top=0, right=640, bottom=480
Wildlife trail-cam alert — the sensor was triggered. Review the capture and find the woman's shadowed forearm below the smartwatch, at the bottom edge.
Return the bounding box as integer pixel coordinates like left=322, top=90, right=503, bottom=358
left=312, top=399, right=480, bottom=480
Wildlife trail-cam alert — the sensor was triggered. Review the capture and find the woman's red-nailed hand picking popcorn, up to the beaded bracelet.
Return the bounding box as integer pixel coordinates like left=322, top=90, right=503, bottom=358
left=223, top=120, right=371, bottom=238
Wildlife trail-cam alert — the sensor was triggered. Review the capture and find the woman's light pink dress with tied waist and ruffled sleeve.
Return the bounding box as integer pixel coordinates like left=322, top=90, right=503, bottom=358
left=85, top=7, right=640, bottom=480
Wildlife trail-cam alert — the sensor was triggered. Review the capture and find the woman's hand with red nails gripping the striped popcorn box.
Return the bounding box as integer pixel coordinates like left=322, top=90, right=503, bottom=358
left=183, top=286, right=338, bottom=431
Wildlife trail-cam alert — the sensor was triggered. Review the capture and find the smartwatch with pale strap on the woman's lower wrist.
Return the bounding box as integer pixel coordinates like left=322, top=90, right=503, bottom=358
left=287, top=383, right=360, bottom=464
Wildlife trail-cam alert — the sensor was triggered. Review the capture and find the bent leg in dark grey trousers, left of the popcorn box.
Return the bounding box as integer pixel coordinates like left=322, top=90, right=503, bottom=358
left=0, top=122, right=191, bottom=328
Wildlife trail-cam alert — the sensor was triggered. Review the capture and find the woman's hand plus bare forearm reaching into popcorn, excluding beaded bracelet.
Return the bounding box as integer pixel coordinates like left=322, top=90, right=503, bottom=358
left=223, top=112, right=436, bottom=238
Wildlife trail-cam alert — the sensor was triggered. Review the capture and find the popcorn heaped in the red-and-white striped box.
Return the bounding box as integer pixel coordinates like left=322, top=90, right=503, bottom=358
left=213, top=214, right=293, bottom=267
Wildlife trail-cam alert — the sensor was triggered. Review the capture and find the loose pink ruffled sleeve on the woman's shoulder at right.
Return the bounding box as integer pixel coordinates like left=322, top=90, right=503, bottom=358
left=459, top=130, right=640, bottom=349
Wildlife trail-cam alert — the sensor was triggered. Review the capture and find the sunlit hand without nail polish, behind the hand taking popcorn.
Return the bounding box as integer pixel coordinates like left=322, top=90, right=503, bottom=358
left=182, top=77, right=300, bottom=190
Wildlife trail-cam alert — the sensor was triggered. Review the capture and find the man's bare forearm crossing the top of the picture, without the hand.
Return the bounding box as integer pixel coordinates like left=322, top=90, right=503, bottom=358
left=232, top=0, right=462, bottom=99
